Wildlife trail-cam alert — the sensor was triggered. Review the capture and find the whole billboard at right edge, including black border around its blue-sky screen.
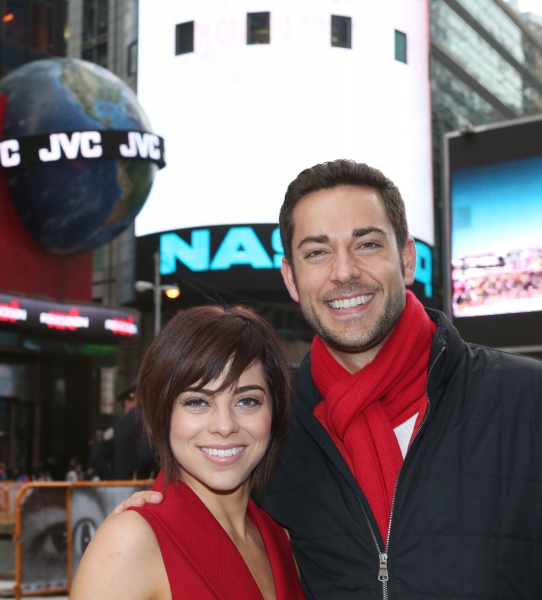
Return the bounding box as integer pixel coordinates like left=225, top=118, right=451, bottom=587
left=448, top=118, right=542, bottom=346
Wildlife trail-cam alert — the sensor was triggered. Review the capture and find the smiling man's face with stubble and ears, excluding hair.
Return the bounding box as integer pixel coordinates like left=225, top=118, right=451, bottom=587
left=282, top=186, right=416, bottom=353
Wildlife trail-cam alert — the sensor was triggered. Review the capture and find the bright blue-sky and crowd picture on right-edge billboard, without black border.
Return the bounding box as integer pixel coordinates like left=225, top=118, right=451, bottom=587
left=451, top=156, right=542, bottom=317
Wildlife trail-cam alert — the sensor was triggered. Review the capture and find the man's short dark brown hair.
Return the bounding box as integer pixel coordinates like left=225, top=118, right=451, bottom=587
left=279, top=158, right=408, bottom=266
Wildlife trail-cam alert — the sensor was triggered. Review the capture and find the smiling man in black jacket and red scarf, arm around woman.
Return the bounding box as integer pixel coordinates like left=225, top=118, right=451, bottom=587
left=115, top=160, right=542, bottom=600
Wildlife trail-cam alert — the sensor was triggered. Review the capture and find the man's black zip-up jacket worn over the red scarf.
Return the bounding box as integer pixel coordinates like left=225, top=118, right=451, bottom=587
left=262, top=310, right=542, bottom=600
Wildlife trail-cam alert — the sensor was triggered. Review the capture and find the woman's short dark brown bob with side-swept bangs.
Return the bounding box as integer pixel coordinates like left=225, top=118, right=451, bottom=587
left=136, top=306, right=291, bottom=495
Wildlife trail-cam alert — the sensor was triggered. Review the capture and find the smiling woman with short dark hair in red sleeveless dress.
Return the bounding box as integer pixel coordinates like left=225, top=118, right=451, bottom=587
left=71, top=306, right=304, bottom=600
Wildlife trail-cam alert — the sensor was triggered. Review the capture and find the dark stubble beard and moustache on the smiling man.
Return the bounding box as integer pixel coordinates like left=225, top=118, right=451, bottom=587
left=301, top=285, right=406, bottom=354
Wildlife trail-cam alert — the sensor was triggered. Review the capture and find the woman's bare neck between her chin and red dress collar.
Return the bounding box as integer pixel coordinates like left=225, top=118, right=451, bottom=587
left=181, top=471, right=250, bottom=541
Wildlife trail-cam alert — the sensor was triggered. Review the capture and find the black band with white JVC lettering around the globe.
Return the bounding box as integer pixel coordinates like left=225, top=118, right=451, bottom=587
left=0, top=131, right=166, bottom=169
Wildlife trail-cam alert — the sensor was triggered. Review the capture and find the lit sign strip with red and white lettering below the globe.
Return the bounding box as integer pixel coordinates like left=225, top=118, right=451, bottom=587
left=0, top=294, right=140, bottom=337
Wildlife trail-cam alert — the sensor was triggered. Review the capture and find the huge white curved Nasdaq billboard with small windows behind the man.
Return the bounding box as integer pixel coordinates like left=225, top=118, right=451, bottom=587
left=136, top=0, right=434, bottom=298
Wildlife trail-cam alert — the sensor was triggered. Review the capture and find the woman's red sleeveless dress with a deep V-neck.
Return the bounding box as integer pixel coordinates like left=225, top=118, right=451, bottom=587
left=128, top=472, right=305, bottom=600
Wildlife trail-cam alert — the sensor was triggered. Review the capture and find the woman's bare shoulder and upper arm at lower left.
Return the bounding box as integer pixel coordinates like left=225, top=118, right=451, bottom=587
left=70, top=510, right=171, bottom=600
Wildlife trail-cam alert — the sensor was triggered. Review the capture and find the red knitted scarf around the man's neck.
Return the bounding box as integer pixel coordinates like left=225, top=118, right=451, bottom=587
left=311, top=292, right=436, bottom=541
